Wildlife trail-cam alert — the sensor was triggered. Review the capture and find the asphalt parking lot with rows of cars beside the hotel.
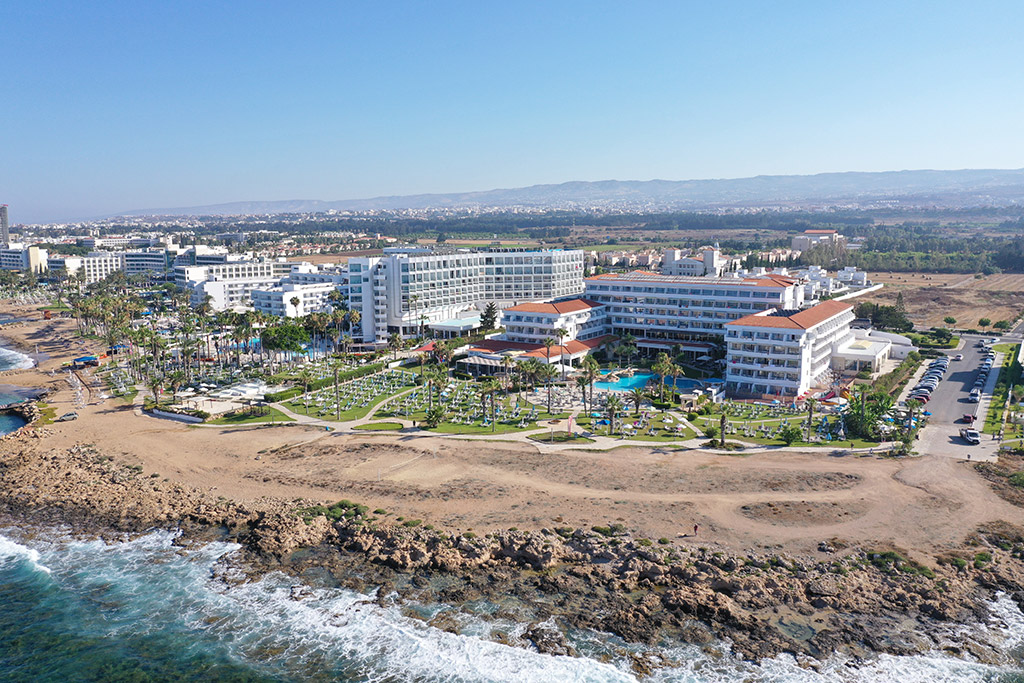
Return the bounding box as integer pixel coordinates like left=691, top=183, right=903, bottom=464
left=904, top=336, right=1002, bottom=461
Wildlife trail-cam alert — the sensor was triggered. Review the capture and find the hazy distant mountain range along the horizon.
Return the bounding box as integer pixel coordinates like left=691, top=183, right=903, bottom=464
left=121, top=169, right=1024, bottom=216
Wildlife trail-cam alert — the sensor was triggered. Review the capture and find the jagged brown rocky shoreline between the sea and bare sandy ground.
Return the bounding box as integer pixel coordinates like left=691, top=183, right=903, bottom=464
left=0, top=429, right=1024, bottom=673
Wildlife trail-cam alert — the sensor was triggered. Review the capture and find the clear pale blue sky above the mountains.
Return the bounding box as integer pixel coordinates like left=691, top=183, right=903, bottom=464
left=0, top=0, right=1024, bottom=222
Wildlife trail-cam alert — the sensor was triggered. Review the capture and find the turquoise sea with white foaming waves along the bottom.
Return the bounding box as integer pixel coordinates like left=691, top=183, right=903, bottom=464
left=0, top=527, right=1024, bottom=683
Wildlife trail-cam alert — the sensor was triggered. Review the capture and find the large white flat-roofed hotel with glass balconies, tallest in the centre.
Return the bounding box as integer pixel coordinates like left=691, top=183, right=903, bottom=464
left=348, top=248, right=584, bottom=343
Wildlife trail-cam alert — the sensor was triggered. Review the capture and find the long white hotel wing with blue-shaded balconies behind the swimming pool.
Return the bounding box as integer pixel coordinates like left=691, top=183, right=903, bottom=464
left=585, top=271, right=804, bottom=353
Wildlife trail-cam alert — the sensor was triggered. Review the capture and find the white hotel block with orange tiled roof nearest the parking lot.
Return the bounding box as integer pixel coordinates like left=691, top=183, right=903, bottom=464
left=725, top=301, right=860, bottom=398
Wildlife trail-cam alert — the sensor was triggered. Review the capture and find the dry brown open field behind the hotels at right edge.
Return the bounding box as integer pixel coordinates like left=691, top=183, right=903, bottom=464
left=858, top=272, right=1024, bottom=327
